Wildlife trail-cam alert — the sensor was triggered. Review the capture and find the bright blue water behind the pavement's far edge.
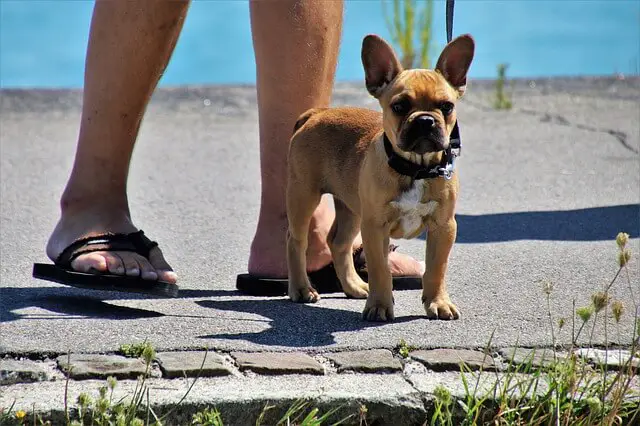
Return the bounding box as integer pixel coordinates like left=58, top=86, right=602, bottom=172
left=0, top=0, right=640, bottom=88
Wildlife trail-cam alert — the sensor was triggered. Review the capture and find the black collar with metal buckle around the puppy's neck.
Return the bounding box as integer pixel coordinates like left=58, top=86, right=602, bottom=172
left=384, top=122, right=461, bottom=180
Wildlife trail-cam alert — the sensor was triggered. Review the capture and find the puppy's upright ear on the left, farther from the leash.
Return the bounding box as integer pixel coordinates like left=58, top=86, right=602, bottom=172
left=362, top=34, right=402, bottom=98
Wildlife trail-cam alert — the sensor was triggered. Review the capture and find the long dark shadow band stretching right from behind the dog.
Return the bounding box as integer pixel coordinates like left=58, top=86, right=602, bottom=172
left=420, top=204, right=640, bottom=244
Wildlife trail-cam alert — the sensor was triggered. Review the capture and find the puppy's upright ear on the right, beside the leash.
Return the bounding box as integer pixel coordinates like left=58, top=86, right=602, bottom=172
left=436, top=34, right=475, bottom=96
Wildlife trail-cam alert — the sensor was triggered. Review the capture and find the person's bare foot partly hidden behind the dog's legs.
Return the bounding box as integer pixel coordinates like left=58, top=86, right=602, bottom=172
left=248, top=198, right=424, bottom=278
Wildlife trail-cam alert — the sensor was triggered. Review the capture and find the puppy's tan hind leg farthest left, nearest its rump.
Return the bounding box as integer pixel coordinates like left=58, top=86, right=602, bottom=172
left=287, top=174, right=321, bottom=303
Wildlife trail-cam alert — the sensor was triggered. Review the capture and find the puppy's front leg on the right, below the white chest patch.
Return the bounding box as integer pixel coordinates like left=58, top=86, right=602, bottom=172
left=422, top=217, right=460, bottom=320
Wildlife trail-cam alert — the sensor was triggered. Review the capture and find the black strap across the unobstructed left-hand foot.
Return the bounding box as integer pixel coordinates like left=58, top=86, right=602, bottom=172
left=55, top=230, right=158, bottom=268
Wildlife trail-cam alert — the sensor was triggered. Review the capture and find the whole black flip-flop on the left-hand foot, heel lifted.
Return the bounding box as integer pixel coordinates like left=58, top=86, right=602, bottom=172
left=33, top=230, right=178, bottom=297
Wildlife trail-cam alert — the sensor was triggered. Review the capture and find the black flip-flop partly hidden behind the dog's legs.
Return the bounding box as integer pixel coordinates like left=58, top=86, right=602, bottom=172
left=236, top=244, right=422, bottom=296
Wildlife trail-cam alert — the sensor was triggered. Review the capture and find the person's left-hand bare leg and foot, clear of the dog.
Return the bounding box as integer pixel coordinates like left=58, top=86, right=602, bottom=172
left=47, top=0, right=189, bottom=282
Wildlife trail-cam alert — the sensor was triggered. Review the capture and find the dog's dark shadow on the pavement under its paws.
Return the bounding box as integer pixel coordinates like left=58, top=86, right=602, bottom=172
left=196, top=298, right=426, bottom=347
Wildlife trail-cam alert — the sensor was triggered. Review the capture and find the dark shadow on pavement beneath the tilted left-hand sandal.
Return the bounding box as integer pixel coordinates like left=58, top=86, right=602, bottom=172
left=0, top=287, right=238, bottom=323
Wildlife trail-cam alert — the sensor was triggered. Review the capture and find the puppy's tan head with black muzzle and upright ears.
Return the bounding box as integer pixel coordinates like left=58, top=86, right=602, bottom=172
left=362, top=34, right=475, bottom=159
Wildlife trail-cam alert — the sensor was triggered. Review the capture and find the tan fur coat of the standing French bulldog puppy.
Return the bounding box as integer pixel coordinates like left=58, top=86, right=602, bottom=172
left=287, top=34, right=476, bottom=321
